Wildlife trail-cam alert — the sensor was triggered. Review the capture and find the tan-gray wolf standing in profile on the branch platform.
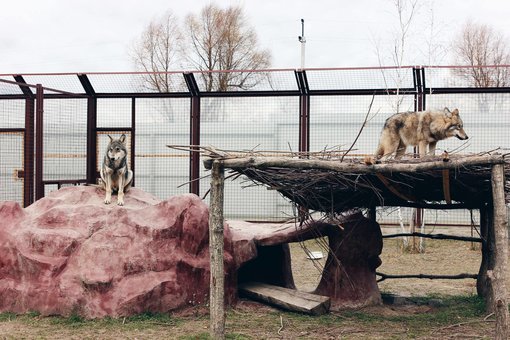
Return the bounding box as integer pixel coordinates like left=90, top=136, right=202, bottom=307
left=375, top=107, right=468, bottom=159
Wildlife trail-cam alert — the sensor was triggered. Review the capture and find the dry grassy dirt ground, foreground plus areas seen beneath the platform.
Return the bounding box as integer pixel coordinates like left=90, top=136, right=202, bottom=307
left=0, top=224, right=510, bottom=339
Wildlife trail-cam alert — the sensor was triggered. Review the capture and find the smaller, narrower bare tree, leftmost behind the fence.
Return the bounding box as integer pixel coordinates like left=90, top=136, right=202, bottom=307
left=132, top=12, right=182, bottom=92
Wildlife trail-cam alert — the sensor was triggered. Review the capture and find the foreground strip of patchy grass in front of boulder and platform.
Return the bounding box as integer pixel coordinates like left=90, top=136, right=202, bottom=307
left=0, top=296, right=493, bottom=340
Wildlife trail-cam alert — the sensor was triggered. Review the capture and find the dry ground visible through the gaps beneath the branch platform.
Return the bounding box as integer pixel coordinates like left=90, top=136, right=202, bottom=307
left=291, top=227, right=490, bottom=296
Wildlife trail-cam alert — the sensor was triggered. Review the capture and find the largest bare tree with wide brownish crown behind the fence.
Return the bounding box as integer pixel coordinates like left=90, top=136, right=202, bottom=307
left=185, top=5, right=271, bottom=91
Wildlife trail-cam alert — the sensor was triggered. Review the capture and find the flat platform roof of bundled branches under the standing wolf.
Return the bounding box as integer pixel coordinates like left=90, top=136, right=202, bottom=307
left=169, top=147, right=510, bottom=213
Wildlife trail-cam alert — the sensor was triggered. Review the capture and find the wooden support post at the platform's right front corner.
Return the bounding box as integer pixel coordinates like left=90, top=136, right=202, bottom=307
left=487, top=164, right=510, bottom=339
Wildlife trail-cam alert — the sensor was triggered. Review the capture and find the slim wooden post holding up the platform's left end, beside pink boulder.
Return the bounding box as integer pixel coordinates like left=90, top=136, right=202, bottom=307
left=209, top=160, right=225, bottom=339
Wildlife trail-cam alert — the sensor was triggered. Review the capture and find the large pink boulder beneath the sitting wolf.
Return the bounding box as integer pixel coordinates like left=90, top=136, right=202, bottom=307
left=0, top=186, right=237, bottom=318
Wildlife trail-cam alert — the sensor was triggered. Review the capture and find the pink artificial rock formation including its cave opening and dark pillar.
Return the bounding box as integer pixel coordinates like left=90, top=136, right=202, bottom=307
left=0, top=186, right=382, bottom=318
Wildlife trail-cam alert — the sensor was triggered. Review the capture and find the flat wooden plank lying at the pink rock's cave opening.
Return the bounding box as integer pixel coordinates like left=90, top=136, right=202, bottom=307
left=239, top=282, right=331, bottom=315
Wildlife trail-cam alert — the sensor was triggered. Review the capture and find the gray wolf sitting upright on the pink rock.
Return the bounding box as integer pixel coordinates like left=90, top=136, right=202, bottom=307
left=100, top=134, right=133, bottom=205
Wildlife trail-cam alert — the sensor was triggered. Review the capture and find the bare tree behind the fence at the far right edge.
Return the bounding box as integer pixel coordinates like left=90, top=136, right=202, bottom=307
left=454, top=21, right=510, bottom=87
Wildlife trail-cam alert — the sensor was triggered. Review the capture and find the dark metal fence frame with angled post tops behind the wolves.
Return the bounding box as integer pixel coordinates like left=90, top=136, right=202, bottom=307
left=0, top=67, right=510, bottom=210
